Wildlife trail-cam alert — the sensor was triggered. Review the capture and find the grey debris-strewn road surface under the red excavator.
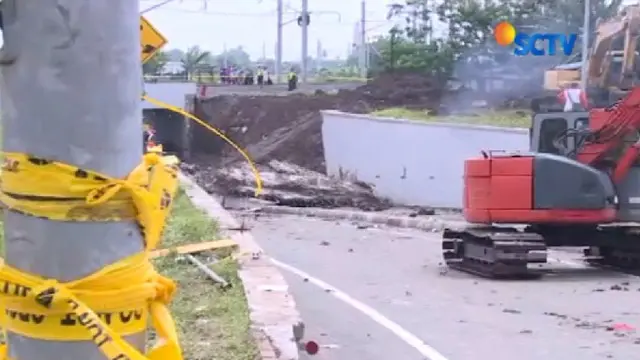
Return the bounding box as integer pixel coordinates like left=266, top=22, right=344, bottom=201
left=236, top=215, right=640, bottom=360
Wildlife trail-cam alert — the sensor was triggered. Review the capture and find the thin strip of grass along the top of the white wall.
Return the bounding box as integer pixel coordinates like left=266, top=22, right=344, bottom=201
left=371, top=108, right=531, bottom=128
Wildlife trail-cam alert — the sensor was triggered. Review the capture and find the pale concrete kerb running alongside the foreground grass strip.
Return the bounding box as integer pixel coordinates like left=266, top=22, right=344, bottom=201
left=179, top=173, right=304, bottom=360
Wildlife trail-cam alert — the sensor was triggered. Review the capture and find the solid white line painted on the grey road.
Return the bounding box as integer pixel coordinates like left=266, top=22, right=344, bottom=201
left=271, top=258, right=448, bottom=360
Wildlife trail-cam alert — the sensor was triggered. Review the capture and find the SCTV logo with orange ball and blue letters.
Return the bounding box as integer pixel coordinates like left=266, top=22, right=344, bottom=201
left=493, top=21, right=578, bottom=56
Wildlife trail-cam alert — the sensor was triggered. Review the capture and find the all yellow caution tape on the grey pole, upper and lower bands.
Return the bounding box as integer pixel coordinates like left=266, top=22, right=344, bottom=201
left=0, top=153, right=182, bottom=360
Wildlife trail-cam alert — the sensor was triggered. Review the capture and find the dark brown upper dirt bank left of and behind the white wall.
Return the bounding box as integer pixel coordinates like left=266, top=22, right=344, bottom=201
left=192, top=74, right=444, bottom=172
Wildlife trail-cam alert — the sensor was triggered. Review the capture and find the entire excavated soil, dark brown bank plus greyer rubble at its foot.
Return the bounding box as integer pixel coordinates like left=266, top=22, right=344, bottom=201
left=183, top=74, right=464, bottom=211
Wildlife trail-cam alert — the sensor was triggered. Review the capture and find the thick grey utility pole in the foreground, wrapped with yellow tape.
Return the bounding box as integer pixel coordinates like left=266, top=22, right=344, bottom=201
left=0, top=0, right=145, bottom=360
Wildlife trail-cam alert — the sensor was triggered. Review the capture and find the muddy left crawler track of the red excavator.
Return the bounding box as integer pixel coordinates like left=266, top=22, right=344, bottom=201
left=442, top=227, right=547, bottom=279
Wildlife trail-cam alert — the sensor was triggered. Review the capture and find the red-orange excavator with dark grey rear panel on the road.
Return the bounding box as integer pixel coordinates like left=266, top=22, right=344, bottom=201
left=442, top=87, right=640, bottom=278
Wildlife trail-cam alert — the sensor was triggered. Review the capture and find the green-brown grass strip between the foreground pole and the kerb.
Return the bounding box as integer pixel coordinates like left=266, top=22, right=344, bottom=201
left=155, top=189, right=259, bottom=360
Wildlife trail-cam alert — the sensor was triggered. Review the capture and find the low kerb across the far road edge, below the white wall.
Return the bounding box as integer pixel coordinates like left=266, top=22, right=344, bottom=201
left=258, top=206, right=465, bottom=232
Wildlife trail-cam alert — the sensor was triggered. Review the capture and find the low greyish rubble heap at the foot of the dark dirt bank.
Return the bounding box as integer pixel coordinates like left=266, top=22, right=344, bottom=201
left=182, top=161, right=391, bottom=211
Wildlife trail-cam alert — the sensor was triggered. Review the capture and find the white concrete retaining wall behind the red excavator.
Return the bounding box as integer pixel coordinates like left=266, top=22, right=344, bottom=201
left=322, top=110, right=529, bottom=208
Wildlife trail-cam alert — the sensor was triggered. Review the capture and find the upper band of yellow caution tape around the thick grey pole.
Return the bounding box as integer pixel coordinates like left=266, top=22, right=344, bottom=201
left=0, top=153, right=179, bottom=248
